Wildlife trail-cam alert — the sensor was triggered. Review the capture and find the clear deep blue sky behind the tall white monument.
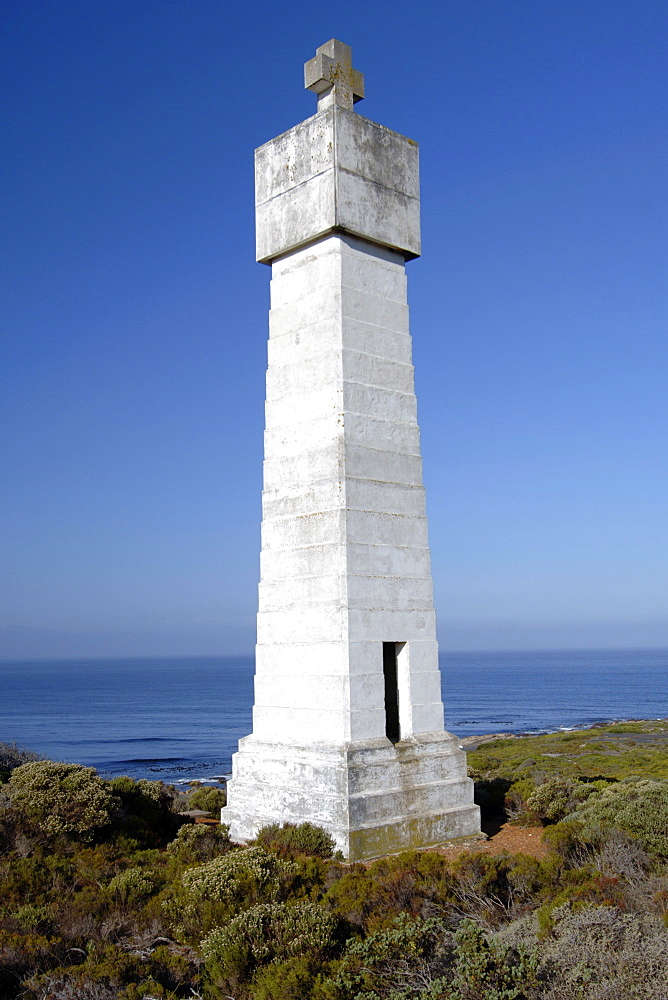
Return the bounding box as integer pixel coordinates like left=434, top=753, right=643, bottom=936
left=0, top=0, right=668, bottom=658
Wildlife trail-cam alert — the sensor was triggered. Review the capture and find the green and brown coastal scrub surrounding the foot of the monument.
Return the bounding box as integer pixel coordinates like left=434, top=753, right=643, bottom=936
left=0, top=723, right=668, bottom=1000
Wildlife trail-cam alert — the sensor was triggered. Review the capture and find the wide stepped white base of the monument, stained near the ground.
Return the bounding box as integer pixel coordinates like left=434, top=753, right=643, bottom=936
left=221, top=732, right=480, bottom=861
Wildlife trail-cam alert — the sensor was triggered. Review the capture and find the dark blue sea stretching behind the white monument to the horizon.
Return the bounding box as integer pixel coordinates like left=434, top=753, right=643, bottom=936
left=0, top=650, right=668, bottom=782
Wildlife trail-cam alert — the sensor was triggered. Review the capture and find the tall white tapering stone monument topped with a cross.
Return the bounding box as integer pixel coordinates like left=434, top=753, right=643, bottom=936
left=222, top=40, right=480, bottom=859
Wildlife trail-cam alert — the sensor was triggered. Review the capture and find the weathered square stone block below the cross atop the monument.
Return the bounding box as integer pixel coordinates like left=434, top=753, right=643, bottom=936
left=255, top=107, right=420, bottom=264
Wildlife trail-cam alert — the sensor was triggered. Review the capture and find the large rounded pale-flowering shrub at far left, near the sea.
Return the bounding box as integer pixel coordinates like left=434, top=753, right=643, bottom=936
left=9, top=760, right=114, bottom=841
